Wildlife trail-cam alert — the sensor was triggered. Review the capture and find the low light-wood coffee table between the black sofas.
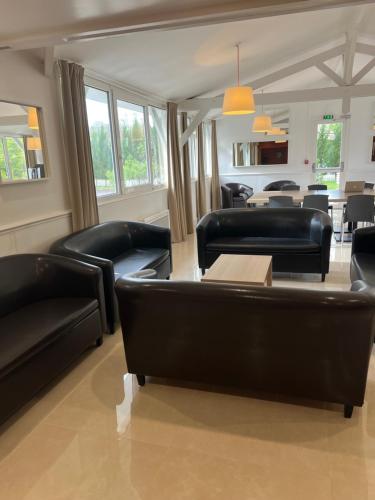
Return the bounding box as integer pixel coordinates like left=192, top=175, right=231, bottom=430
left=202, top=254, right=272, bottom=286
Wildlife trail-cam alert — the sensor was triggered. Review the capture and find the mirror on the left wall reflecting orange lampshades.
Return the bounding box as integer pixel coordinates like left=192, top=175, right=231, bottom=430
left=0, top=101, right=46, bottom=184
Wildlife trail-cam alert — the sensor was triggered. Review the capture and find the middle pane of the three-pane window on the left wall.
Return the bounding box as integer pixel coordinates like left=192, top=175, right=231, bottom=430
left=117, top=99, right=150, bottom=187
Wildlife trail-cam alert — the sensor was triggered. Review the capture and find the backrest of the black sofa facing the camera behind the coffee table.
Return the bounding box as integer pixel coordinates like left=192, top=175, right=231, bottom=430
left=212, top=208, right=320, bottom=239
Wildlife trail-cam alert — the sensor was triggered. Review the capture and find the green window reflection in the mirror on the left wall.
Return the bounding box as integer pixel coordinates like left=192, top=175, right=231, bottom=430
left=0, top=136, right=28, bottom=181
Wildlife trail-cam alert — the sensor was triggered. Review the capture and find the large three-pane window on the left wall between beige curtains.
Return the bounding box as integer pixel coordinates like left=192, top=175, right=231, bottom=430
left=86, top=84, right=168, bottom=197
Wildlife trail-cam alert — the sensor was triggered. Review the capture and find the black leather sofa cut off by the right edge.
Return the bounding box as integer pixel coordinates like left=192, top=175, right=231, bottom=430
left=350, top=226, right=375, bottom=290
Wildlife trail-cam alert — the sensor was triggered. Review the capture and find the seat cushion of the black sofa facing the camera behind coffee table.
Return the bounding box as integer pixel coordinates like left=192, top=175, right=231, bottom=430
left=207, top=236, right=320, bottom=254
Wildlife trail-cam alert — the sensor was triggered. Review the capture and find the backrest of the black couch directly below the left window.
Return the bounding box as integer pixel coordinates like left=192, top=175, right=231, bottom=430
left=57, top=221, right=132, bottom=260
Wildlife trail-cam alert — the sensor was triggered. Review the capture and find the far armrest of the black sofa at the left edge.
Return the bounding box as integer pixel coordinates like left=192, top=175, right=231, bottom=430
left=38, top=255, right=106, bottom=331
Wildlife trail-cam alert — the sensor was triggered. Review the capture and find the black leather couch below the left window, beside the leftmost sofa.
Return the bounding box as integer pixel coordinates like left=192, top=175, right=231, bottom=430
left=50, top=221, right=172, bottom=333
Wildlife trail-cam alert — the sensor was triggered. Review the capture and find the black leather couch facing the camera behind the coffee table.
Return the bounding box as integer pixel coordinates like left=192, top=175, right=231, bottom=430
left=197, top=208, right=332, bottom=281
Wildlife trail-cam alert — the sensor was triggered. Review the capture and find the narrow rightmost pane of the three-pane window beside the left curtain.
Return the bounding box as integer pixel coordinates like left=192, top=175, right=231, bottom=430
left=148, top=106, right=168, bottom=185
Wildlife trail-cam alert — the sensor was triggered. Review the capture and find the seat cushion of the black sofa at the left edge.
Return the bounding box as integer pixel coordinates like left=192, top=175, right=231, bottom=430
left=0, top=297, right=98, bottom=377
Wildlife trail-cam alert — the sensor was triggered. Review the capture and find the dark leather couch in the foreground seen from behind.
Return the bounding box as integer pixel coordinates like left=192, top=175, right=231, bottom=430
left=116, top=279, right=375, bottom=417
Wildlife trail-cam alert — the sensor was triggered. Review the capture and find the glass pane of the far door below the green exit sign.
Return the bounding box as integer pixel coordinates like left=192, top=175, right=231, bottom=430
left=315, top=122, right=343, bottom=189
